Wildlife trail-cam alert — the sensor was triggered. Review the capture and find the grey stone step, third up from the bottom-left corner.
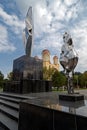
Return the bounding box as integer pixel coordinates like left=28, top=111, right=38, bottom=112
left=0, top=99, right=19, bottom=111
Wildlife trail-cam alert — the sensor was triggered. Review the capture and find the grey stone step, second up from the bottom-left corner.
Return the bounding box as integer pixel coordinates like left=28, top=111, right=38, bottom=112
left=0, top=105, right=19, bottom=122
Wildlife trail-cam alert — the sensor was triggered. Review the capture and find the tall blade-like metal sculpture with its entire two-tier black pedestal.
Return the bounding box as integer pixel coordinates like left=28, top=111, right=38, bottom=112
left=4, top=7, right=51, bottom=93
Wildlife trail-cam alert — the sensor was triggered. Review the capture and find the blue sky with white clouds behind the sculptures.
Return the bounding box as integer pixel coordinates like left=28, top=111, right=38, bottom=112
left=0, top=0, right=87, bottom=77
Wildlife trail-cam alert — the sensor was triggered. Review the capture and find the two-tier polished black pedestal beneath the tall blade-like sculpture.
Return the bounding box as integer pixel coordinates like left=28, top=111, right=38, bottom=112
left=3, top=55, right=52, bottom=94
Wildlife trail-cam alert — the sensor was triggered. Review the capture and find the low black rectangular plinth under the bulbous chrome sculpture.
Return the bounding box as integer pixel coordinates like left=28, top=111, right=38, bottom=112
left=59, top=94, right=84, bottom=102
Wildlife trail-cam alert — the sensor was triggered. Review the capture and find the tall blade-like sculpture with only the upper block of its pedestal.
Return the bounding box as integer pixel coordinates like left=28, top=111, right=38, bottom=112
left=13, top=6, right=43, bottom=80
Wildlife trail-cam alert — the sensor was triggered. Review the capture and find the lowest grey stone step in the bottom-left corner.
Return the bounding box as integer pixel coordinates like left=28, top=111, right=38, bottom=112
left=0, top=112, right=18, bottom=130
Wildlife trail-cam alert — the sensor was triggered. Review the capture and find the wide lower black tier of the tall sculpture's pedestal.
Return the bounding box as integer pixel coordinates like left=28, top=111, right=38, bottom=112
left=3, top=79, right=52, bottom=94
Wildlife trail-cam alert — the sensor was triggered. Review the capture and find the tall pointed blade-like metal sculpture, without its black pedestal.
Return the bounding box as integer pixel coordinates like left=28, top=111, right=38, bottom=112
left=23, top=7, right=33, bottom=57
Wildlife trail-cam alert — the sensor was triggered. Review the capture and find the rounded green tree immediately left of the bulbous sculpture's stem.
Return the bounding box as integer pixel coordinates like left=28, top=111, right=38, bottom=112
left=52, top=71, right=66, bottom=89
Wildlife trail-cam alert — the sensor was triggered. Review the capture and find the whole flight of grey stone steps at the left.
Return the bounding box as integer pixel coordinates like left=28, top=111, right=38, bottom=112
left=0, top=92, right=36, bottom=130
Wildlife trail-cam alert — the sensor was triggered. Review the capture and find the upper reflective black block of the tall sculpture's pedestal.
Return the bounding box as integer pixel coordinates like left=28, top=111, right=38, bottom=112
left=13, top=55, right=43, bottom=80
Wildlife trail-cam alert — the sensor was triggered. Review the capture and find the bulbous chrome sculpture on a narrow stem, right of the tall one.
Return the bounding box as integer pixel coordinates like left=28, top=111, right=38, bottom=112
left=60, top=32, right=78, bottom=94
